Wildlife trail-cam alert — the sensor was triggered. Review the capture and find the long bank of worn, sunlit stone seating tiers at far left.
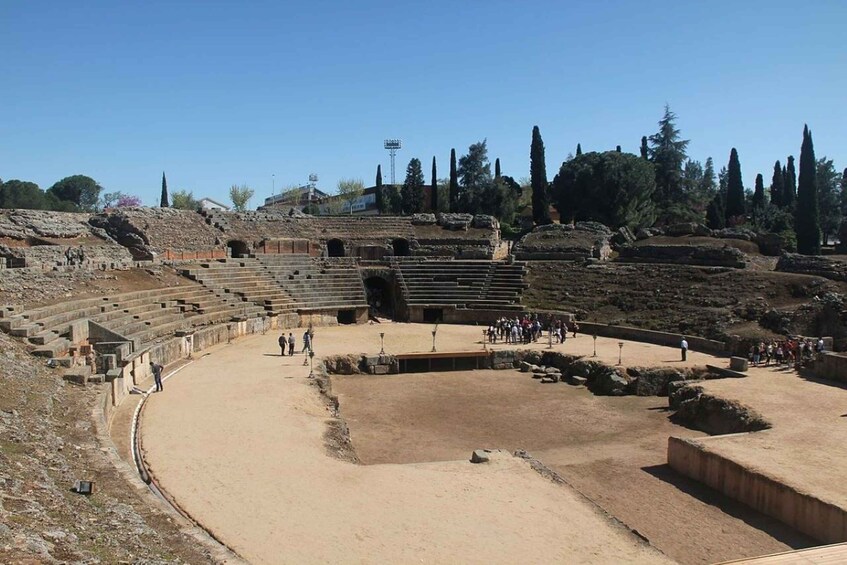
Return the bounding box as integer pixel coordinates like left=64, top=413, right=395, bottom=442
left=0, top=285, right=263, bottom=357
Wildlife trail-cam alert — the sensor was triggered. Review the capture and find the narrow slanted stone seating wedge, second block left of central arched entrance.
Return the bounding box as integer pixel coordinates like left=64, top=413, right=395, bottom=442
left=181, top=258, right=296, bottom=314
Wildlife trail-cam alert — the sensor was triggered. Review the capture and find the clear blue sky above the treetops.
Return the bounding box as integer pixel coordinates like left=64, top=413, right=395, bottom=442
left=0, top=0, right=847, bottom=207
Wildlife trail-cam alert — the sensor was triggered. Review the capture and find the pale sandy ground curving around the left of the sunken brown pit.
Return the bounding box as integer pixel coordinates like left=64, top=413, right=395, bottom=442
left=142, top=324, right=666, bottom=563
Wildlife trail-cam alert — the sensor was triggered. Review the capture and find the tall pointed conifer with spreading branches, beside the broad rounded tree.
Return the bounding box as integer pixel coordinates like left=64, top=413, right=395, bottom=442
left=649, top=104, right=688, bottom=208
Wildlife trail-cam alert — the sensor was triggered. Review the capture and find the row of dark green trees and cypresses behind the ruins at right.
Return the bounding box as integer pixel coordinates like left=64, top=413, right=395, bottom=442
left=376, top=106, right=847, bottom=254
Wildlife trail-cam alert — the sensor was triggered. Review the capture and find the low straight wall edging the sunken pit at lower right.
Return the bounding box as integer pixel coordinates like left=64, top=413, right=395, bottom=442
left=668, top=432, right=847, bottom=543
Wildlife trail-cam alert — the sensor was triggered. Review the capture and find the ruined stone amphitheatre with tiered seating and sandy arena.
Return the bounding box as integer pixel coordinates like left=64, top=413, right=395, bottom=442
left=0, top=208, right=847, bottom=563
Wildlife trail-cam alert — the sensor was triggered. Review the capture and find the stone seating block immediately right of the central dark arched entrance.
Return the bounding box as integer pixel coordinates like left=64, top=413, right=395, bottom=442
left=394, top=260, right=526, bottom=309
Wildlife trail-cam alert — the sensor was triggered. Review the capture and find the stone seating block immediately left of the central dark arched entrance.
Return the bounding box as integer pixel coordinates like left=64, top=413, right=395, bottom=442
left=256, top=254, right=368, bottom=311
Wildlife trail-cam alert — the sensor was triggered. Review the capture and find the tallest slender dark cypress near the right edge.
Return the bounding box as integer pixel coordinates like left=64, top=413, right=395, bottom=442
left=788, top=126, right=821, bottom=255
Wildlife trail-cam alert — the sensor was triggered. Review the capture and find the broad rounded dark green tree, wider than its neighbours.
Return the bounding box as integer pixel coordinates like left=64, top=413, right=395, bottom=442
left=552, top=151, right=656, bottom=228
